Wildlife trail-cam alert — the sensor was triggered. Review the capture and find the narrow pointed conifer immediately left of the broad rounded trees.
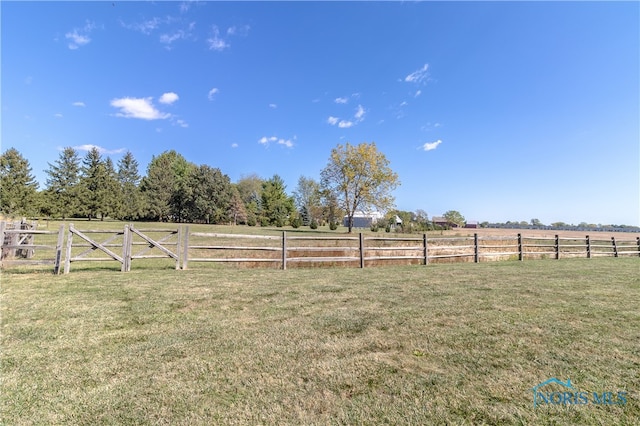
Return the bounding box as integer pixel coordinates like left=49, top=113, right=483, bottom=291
left=118, top=151, right=144, bottom=220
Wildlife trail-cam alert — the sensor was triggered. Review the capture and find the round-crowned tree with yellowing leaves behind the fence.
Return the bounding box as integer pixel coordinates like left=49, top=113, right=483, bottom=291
left=320, top=143, right=400, bottom=232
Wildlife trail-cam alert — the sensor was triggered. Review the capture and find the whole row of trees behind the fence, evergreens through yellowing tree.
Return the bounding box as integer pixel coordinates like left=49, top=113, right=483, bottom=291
left=0, top=143, right=399, bottom=230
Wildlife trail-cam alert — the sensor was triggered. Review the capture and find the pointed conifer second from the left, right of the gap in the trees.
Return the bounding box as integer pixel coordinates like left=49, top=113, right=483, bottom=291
left=44, top=147, right=80, bottom=219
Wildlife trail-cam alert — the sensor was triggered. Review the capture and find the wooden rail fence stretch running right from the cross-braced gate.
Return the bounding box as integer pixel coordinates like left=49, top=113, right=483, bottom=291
left=182, top=227, right=640, bottom=269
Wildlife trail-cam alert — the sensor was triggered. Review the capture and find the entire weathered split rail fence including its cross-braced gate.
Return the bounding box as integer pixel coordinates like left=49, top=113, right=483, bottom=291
left=0, top=222, right=640, bottom=274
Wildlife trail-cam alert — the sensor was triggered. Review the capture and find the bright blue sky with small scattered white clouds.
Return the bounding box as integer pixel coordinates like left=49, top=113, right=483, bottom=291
left=0, top=1, right=640, bottom=225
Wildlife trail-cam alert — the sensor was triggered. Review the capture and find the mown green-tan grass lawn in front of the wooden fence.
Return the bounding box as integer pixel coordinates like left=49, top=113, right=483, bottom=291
left=0, top=258, right=640, bottom=425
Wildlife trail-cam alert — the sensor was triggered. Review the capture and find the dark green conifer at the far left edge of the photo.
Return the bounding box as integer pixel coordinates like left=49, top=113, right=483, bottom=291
left=0, top=148, right=38, bottom=215
